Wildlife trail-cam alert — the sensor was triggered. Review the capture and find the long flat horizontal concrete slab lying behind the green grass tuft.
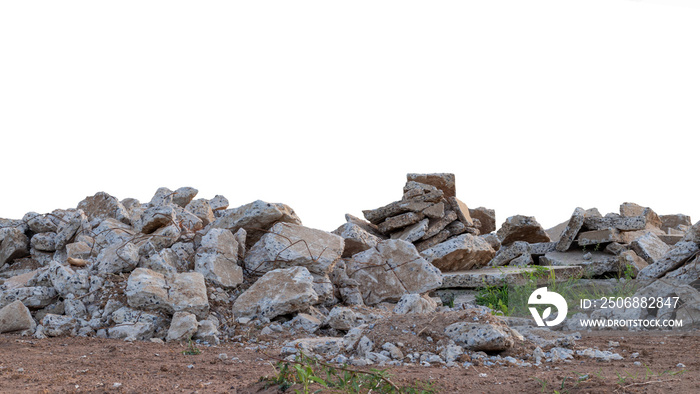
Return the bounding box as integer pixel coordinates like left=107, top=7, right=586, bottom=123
left=440, top=266, right=583, bottom=289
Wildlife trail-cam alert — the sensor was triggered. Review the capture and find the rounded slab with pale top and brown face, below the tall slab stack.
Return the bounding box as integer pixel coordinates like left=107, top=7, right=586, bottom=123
left=420, top=234, right=496, bottom=272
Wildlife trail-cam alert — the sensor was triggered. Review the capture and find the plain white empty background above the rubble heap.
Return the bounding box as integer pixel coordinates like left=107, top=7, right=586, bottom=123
left=0, top=0, right=700, bottom=230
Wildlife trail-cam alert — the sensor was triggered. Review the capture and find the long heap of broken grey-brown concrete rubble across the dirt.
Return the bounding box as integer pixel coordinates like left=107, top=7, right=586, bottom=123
left=0, top=173, right=700, bottom=367
